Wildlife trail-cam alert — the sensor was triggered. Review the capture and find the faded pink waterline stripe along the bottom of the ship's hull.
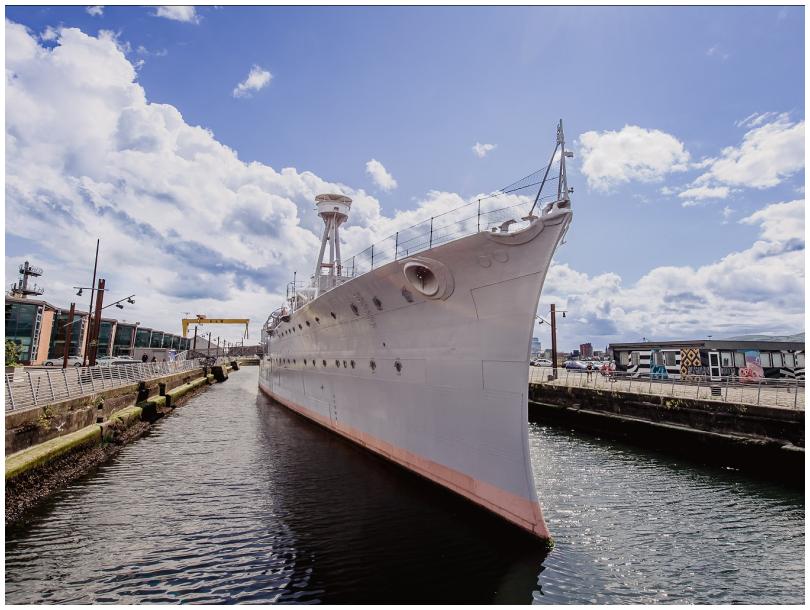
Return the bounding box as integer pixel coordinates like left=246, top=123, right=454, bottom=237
left=259, top=383, right=551, bottom=539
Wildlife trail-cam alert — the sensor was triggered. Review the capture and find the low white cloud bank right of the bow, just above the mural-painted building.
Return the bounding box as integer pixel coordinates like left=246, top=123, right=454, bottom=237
left=540, top=201, right=804, bottom=346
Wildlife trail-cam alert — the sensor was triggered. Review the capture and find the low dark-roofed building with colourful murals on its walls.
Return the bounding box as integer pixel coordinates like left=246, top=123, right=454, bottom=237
left=608, top=339, right=804, bottom=380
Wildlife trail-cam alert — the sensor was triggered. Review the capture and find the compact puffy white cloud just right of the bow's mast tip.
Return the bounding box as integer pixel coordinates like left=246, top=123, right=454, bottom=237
left=577, top=125, right=689, bottom=191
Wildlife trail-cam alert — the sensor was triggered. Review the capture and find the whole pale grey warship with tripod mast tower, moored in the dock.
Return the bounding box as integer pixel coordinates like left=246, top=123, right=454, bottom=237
left=259, top=121, right=573, bottom=541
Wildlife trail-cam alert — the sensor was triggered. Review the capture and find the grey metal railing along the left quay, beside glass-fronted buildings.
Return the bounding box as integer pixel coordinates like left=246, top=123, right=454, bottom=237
left=5, top=357, right=229, bottom=411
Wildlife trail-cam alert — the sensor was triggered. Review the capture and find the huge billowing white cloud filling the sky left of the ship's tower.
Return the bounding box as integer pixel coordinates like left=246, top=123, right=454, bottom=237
left=6, top=22, right=370, bottom=332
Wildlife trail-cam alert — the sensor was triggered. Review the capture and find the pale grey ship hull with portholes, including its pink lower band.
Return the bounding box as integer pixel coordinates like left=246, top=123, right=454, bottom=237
left=259, top=209, right=571, bottom=538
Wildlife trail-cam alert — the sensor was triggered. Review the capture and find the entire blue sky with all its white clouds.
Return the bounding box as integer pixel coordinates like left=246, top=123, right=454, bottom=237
left=5, top=6, right=805, bottom=349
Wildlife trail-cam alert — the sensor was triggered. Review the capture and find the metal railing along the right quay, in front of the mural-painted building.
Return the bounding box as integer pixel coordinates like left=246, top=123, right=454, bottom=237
left=529, top=367, right=804, bottom=411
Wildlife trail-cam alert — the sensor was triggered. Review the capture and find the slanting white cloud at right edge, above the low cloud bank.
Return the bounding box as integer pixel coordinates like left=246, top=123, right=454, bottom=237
left=695, top=113, right=804, bottom=189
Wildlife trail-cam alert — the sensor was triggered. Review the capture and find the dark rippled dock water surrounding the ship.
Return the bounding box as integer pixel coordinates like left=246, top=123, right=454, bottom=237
left=6, top=368, right=804, bottom=603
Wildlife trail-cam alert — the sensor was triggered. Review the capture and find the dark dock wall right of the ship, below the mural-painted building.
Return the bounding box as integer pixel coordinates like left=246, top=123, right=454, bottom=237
left=529, top=384, right=804, bottom=482
